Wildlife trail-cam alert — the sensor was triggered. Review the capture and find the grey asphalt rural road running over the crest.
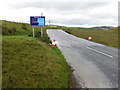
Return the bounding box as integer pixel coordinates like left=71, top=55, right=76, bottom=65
left=47, top=29, right=118, bottom=88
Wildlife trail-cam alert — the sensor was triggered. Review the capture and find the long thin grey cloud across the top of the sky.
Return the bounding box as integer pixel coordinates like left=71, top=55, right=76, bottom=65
left=12, top=2, right=109, bottom=11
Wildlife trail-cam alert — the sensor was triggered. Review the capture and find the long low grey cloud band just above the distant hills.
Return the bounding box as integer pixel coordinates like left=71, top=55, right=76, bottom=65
left=52, top=14, right=117, bottom=25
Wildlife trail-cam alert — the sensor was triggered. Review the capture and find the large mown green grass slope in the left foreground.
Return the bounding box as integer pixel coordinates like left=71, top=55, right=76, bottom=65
left=2, top=35, right=70, bottom=88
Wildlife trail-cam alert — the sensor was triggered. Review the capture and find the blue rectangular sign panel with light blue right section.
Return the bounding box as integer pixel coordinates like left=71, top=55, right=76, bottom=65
left=30, top=16, right=45, bottom=27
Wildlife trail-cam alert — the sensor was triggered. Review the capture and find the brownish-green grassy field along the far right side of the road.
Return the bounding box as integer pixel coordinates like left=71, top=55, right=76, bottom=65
left=62, top=28, right=120, bottom=49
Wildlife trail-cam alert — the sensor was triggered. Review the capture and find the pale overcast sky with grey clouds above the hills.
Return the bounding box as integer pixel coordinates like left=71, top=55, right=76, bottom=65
left=0, top=0, right=118, bottom=26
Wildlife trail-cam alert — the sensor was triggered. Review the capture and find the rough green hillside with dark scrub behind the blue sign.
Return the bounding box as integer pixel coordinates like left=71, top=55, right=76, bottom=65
left=2, top=21, right=32, bottom=35
